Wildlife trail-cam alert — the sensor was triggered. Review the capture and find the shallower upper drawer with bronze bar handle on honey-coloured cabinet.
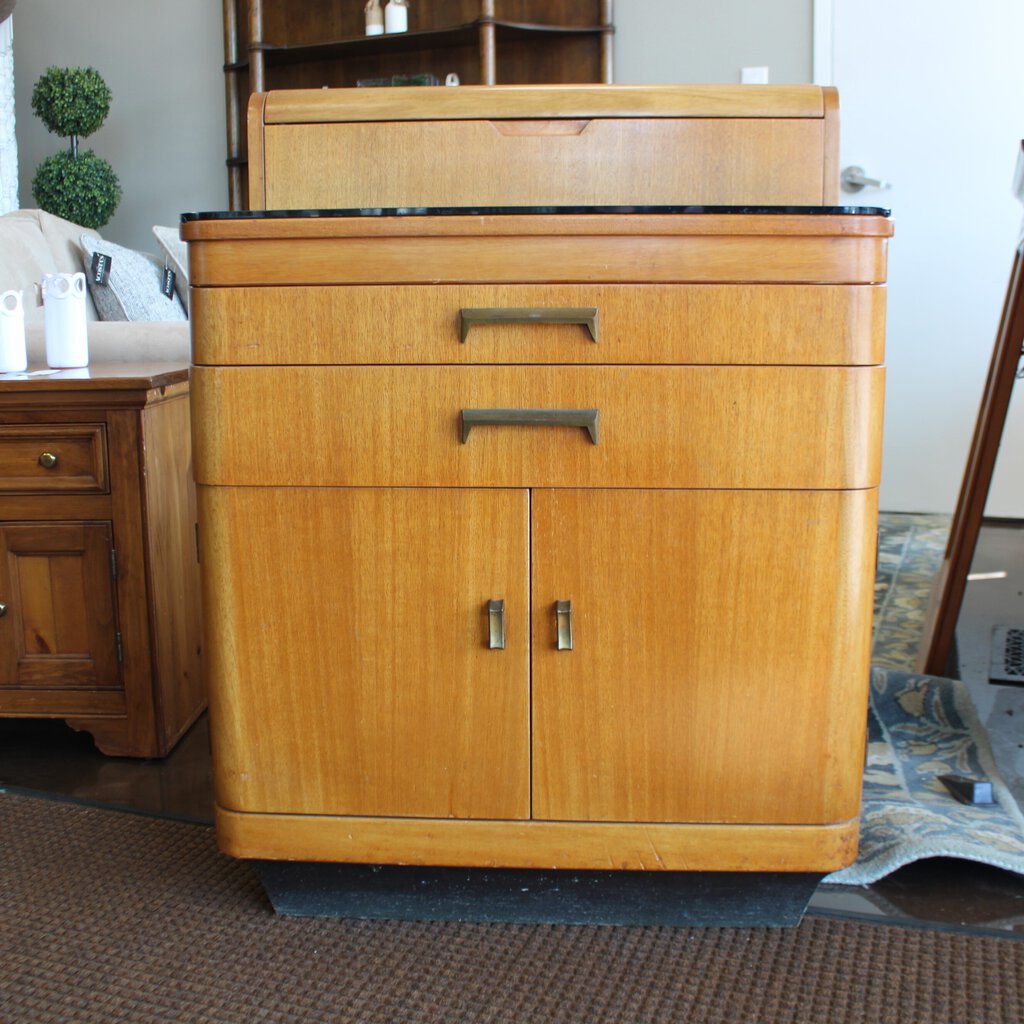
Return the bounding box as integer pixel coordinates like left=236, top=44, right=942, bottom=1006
left=191, top=285, right=886, bottom=366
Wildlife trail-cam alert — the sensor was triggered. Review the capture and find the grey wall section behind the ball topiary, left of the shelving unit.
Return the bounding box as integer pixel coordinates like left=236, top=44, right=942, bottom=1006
left=13, top=0, right=227, bottom=252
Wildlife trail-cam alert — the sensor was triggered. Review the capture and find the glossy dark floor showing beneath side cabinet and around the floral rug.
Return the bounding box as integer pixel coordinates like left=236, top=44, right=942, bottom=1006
left=0, top=522, right=1024, bottom=935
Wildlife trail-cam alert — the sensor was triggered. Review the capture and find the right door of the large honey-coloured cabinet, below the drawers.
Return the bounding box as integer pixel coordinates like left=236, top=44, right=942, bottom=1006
left=532, top=489, right=876, bottom=823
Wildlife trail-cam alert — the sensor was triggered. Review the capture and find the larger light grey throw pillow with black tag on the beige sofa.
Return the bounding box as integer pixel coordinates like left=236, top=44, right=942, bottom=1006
left=81, top=232, right=187, bottom=321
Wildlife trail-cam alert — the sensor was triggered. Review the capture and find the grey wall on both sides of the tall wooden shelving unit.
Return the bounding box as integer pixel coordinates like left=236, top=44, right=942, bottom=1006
left=13, top=0, right=811, bottom=252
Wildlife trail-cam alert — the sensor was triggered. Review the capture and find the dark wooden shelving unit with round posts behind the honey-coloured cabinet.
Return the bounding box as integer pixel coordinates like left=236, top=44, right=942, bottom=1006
left=223, top=0, right=614, bottom=210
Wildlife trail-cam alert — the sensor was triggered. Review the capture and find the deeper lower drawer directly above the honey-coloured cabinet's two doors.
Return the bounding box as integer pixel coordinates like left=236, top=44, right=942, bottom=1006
left=193, top=366, right=884, bottom=488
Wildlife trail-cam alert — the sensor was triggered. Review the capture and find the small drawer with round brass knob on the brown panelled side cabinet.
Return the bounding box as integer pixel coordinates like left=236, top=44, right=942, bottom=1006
left=0, top=423, right=108, bottom=494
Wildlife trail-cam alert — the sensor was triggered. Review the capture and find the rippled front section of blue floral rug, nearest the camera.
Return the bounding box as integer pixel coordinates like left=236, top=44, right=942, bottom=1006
left=824, top=669, right=1024, bottom=885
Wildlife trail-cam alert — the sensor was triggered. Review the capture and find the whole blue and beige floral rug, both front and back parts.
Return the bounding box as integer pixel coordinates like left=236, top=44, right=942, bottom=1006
left=824, top=513, right=1024, bottom=885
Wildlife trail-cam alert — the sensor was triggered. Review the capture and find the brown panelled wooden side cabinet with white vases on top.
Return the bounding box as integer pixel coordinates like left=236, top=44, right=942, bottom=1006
left=0, top=365, right=205, bottom=757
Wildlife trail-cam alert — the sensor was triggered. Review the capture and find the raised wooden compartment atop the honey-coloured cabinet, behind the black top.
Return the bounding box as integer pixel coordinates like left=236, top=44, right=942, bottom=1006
left=249, top=86, right=839, bottom=209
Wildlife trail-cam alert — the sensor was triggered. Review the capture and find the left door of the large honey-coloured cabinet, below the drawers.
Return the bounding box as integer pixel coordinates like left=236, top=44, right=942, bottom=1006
left=199, top=487, right=529, bottom=818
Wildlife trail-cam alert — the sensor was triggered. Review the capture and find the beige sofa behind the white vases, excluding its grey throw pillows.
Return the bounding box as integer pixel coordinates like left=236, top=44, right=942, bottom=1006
left=0, top=210, right=190, bottom=369
